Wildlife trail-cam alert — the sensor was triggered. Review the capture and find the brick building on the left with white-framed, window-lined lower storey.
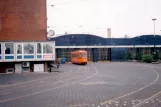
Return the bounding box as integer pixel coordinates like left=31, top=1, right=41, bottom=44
left=0, top=0, right=55, bottom=73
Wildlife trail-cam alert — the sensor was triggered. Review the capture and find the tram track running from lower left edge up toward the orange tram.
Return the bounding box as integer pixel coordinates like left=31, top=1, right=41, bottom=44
left=0, top=64, right=94, bottom=103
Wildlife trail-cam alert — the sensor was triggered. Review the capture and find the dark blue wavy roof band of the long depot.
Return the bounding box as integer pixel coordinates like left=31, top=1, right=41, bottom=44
left=50, top=34, right=161, bottom=46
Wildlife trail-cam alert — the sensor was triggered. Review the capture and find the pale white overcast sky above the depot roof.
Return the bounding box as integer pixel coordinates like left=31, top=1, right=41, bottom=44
left=47, top=0, right=161, bottom=38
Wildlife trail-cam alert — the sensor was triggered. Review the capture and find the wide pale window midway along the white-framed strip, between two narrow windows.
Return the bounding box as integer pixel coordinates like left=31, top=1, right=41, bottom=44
left=24, top=43, right=34, bottom=54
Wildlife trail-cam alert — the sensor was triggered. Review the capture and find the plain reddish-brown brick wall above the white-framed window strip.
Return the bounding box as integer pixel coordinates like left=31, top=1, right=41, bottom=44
left=0, top=0, right=47, bottom=41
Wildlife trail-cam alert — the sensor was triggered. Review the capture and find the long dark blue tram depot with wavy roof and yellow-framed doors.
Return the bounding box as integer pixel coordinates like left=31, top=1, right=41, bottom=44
left=50, top=34, right=161, bottom=62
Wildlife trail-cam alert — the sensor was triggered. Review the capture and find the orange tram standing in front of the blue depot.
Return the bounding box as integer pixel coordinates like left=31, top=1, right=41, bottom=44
left=71, top=50, right=88, bottom=65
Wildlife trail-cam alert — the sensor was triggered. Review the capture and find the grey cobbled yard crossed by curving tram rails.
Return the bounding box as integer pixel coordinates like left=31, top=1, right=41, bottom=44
left=0, top=62, right=161, bottom=107
